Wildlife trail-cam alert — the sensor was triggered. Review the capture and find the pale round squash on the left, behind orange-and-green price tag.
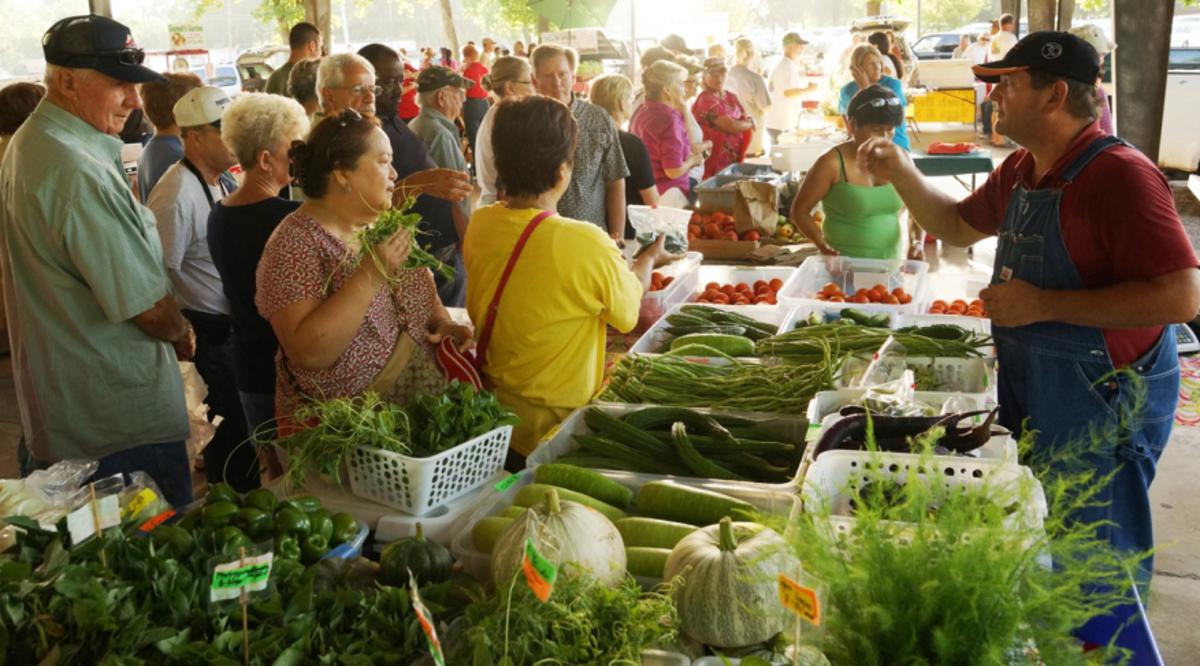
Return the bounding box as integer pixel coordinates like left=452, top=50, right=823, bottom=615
left=492, top=488, right=625, bottom=589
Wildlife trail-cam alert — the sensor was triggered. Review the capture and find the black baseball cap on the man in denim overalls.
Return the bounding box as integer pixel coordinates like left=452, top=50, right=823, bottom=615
left=971, top=30, right=1100, bottom=84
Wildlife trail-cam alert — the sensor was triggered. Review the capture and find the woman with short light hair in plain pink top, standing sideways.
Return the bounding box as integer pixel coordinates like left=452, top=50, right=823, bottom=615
left=629, top=60, right=702, bottom=199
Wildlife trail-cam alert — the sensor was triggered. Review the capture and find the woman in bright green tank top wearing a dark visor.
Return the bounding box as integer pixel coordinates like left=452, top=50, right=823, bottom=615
left=788, top=85, right=920, bottom=259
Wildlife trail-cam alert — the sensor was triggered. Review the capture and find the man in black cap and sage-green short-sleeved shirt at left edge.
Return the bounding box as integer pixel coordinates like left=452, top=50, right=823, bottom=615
left=0, top=16, right=196, bottom=506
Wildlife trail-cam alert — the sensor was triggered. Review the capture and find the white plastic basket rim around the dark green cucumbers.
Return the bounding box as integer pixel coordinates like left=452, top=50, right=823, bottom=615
left=526, top=403, right=811, bottom=492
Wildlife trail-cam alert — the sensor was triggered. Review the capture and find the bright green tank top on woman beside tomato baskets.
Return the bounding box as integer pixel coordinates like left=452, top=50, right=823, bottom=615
left=821, top=148, right=904, bottom=259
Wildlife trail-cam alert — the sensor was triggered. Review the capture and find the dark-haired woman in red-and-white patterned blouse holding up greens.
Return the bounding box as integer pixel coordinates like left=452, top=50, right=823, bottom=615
left=254, top=109, right=470, bottom=419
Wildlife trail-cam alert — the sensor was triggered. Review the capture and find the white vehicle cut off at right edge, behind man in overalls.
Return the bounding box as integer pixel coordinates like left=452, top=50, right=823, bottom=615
left=1158, top=47, right=1200, bottom=172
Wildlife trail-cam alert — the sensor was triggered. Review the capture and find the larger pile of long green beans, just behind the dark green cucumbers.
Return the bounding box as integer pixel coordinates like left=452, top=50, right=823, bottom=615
left=600, top=349, right=840, bottom=414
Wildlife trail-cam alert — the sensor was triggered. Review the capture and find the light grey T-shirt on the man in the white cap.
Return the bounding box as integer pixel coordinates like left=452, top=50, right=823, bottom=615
left=146, top=162, right=229, bottom=314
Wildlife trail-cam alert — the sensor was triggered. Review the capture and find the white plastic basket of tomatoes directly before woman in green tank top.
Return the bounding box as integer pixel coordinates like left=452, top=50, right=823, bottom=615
left=779, top=256, right=929, bottom=313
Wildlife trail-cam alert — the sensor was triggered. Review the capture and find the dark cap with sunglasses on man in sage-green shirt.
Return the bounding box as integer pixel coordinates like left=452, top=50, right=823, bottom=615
left=42, top=14, right=167, bottom=83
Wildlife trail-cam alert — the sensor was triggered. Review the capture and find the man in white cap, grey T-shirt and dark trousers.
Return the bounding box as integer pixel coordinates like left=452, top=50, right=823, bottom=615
left=146, top=85, right=258, bottom=491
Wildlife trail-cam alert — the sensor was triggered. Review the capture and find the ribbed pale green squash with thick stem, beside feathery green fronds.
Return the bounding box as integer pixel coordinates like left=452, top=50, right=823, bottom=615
left=662, top=517, right=799, bottom=648
